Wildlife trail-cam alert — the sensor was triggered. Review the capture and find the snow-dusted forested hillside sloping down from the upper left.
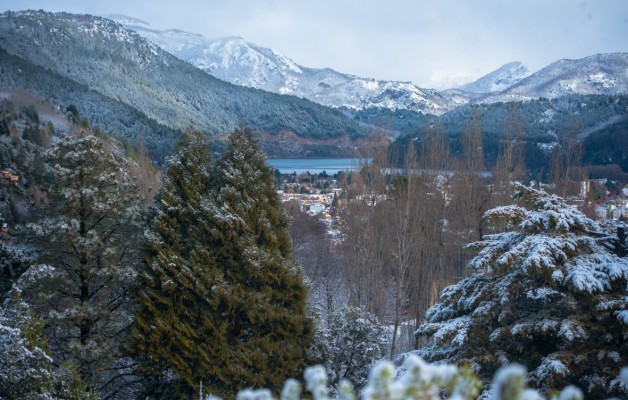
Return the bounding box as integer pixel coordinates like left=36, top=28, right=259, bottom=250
left=0, top=11, right=366, bottom=156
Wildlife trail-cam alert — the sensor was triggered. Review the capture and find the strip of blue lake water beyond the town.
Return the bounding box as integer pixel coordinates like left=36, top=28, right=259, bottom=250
left=266, top=158, right=360, bottom=175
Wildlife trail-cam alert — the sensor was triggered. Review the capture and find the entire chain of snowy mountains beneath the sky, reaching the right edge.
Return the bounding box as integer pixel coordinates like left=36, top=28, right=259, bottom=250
left=119, top=15, right=628, bottom=116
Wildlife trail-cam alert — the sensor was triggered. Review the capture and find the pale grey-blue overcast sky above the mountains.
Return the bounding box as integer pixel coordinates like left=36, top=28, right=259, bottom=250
left=0, top=0, right=628, bottom=89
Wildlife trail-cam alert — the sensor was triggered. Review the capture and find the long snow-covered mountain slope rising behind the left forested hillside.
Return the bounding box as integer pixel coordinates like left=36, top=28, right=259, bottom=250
left=113, top=15, right=452, bottom=115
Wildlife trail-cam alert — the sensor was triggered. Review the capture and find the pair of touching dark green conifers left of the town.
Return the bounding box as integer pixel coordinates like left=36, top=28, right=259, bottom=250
left=131, top=130, right=311, bottom=398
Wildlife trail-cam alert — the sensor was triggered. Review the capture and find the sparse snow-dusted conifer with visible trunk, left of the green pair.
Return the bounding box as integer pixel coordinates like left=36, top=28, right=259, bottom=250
left=18, top=134, right=139, bottom=395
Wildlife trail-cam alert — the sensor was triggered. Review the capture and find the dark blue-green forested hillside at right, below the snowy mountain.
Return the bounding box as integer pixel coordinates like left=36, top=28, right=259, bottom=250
left=378, top=95, right=628, bottom=172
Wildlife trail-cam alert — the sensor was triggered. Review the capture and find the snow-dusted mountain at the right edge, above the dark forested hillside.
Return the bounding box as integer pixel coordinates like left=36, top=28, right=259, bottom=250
left=484, top=53, right=628, bottom=102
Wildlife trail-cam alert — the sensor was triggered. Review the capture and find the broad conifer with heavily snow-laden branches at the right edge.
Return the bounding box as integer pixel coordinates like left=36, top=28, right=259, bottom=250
left=417, top=184, right=628, bottom=398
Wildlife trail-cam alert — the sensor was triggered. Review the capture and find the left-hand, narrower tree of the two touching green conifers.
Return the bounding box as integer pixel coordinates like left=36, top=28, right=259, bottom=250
left=130, top=132, right=217, bottom=398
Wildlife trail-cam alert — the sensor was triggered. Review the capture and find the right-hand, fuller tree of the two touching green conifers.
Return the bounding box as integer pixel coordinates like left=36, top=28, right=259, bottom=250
left=201, top=129, right=312, bottom=395
